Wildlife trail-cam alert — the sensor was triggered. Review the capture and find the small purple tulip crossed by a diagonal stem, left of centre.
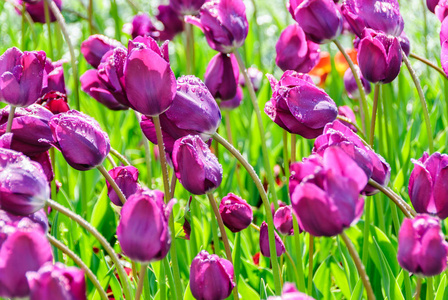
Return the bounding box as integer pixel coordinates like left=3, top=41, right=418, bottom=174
left=107, top=166, right=142, bottom=206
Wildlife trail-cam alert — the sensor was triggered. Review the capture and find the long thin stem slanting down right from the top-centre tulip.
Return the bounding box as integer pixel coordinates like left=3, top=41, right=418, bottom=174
left=233, top=50, right=278, bottom=209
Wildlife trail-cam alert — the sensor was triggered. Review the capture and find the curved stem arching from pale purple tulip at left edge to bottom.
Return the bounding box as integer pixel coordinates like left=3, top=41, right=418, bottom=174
left=47, top=199, right=133, bottom=299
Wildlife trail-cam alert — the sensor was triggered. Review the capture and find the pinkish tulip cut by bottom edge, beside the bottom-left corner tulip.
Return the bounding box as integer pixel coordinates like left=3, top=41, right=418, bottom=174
left=26, top=263, right=87, bottom=300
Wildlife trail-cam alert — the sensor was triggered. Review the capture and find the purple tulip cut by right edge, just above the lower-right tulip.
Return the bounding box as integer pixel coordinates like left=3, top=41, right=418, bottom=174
left=408, top=152, right=448, bottom=219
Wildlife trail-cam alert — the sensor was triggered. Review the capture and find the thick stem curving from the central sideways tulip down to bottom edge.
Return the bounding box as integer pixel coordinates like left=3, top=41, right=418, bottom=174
left=213, top=133, right=282, bottom=295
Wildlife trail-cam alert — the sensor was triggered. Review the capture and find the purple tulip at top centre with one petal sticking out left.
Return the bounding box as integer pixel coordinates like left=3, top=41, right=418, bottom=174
left=186, top=0, right=249, bottom=53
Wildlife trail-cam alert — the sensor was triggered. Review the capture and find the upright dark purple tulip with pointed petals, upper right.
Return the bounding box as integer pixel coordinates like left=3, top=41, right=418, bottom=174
left=358, top=29, right=402, bottom=83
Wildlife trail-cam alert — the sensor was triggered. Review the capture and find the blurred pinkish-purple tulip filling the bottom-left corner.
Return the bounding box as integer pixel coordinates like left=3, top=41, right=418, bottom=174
left=0, top=228, right=53, bottom=298
